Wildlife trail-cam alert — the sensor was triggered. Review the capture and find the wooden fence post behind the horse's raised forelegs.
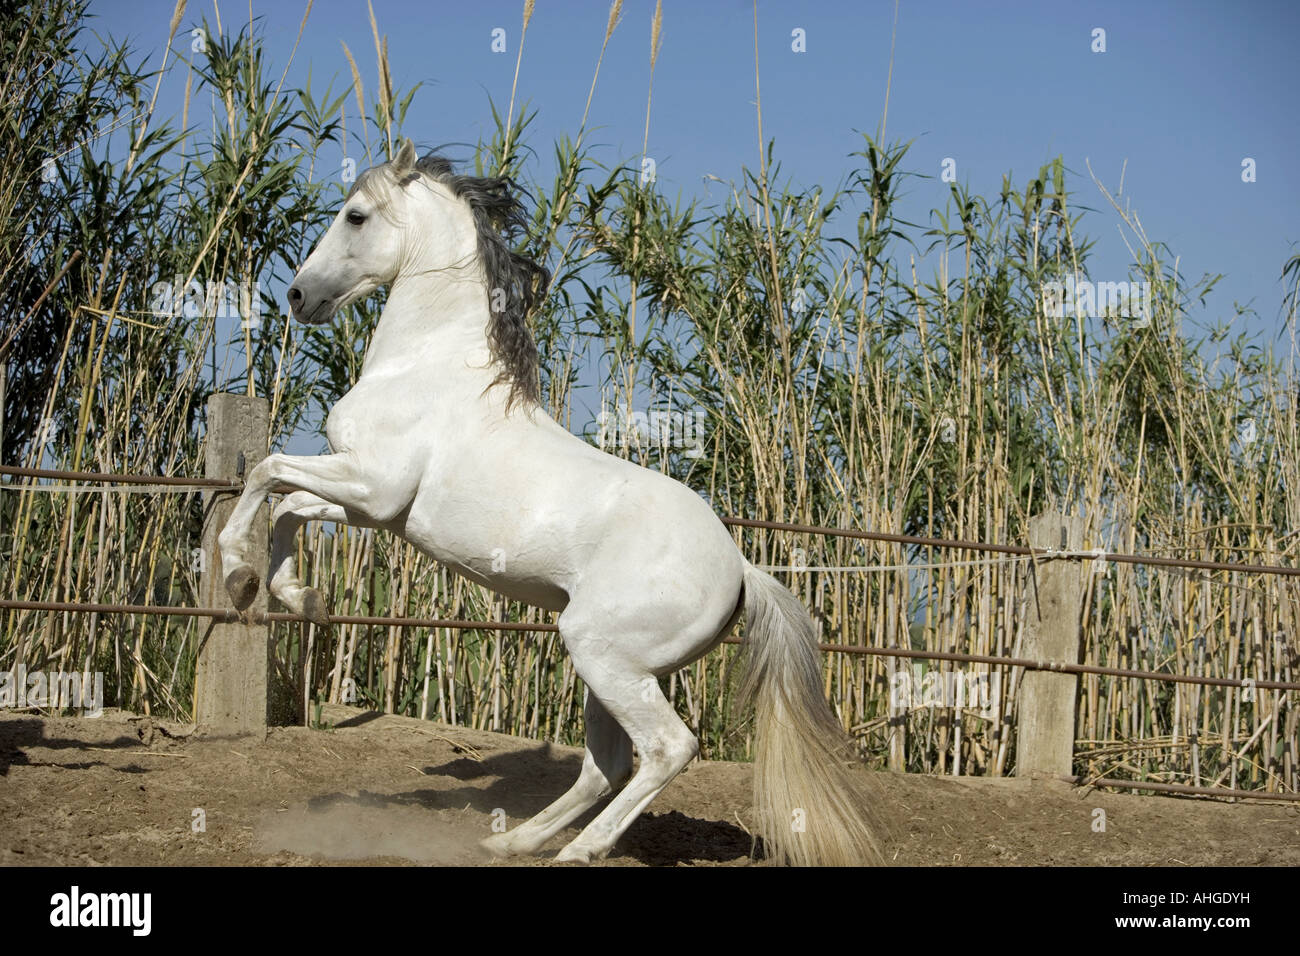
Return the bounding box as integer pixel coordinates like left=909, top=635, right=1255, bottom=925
left=194, top=394, right=273, bottom=736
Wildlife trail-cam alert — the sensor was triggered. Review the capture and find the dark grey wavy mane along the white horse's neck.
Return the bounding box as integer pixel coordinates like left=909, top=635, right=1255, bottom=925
left=415, top=153, right=551, bottom=410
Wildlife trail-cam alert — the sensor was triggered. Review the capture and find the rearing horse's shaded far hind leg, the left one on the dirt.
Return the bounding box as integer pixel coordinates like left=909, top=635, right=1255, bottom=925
left=481, top=691, right=632, bottom=856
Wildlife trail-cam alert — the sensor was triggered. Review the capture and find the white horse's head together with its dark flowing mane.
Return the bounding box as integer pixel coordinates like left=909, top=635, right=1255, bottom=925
left=289, top=139, right=550, bottom=401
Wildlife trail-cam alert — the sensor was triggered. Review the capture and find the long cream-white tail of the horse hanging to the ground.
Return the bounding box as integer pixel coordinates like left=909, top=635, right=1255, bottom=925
left=740, top=564, right=881, bottom=866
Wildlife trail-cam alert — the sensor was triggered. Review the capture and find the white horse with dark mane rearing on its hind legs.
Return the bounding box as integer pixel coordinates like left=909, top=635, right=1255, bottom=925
left=218, top=140, right=879, bottom=865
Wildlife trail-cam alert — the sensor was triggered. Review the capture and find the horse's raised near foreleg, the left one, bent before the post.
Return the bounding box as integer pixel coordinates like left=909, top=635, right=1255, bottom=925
left=217, top=454, right=406, bottom=610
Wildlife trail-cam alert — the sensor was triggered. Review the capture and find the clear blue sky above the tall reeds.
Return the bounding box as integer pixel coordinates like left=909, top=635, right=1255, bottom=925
left=91, top=0, right=1300, bottom=447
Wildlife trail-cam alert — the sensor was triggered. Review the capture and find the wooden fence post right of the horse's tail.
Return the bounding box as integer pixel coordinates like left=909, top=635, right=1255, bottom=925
left=1015, top=514, right=1089, bottom=778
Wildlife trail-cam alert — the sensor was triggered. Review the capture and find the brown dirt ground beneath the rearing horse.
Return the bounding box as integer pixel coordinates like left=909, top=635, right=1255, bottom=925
left=0, top=706, right=1300, bottom=866
